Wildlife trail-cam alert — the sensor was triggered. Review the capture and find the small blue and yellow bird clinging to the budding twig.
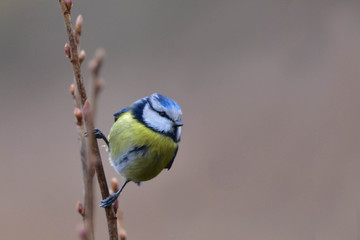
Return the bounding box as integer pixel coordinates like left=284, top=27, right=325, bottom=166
left=94, top=93, right=183, bottom=208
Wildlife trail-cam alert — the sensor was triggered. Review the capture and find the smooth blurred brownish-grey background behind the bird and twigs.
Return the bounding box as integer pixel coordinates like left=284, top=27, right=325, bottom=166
left=0, top=0, right=360, bottom=240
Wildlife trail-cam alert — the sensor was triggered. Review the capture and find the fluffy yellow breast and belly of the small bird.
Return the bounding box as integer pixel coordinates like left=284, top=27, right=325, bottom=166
left=109, top=111, right=177, bottom=182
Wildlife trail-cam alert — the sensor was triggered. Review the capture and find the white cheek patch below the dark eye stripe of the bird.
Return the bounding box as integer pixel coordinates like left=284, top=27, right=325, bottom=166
left=143, top=104, right=172, bottom=132
